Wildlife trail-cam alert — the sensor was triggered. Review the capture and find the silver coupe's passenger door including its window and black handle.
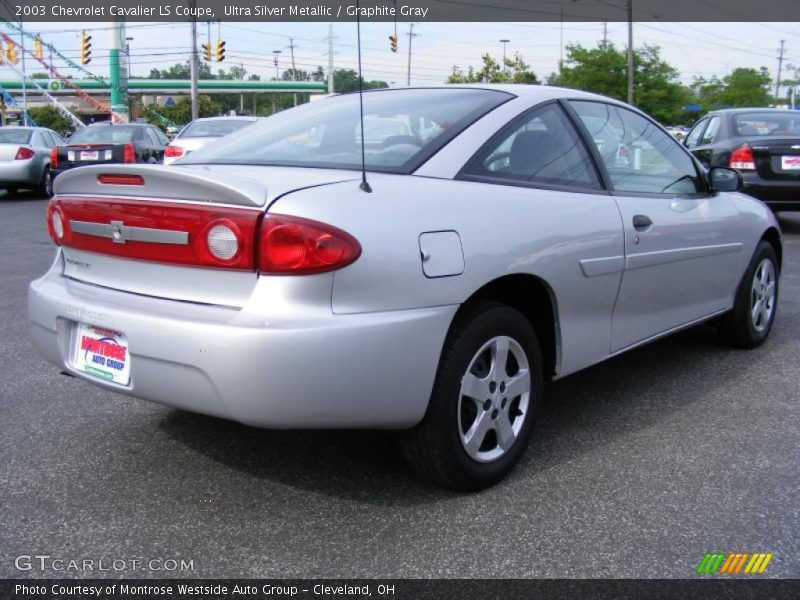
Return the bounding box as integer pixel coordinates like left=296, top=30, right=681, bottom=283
left=570, top=101, right=742, bottom=352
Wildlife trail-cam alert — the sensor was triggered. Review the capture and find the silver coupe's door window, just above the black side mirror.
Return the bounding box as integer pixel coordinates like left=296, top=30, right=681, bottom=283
left=570, top=101, right=702, bottom=194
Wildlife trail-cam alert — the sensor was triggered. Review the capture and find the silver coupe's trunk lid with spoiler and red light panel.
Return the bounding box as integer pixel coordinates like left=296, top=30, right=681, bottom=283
left=48, top=165, right=353, bottom=307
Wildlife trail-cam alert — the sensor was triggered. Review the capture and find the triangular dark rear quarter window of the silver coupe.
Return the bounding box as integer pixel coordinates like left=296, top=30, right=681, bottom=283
left=464, top=104, right=601, bottom=189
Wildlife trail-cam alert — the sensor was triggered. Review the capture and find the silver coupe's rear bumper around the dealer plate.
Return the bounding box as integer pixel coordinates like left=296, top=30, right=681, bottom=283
left=28, top=259, right=457, bottom=428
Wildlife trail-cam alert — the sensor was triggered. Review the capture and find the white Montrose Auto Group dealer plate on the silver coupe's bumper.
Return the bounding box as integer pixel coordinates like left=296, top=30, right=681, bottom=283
left=72, top=323, right=131, bottom=385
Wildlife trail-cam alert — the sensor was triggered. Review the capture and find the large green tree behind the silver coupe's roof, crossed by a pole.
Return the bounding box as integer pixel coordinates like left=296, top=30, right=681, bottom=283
left=547, top=44, right=691, bottom=124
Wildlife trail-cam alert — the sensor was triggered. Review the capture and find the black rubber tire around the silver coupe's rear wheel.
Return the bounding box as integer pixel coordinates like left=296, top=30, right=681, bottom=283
left=400, top=301, right=542, bottom=491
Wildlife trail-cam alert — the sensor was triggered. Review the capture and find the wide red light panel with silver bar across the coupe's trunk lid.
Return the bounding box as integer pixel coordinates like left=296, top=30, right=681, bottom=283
left=48, top=197, right=263, bottom=271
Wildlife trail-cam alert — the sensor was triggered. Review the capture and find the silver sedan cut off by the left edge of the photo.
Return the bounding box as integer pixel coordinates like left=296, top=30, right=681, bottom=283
left=0, top=127, right=64, bottom=198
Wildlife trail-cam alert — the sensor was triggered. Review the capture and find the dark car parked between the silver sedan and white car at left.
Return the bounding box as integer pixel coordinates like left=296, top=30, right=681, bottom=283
left=50, top=122, right=169, bottom=176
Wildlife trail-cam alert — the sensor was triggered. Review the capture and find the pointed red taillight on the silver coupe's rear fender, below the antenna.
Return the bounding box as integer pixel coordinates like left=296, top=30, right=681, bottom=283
left=258, top=215, right=361, bottom=275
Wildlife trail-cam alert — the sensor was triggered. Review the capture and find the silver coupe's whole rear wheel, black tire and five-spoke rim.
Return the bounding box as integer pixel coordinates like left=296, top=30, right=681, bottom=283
left=401, top=302, right=542, bottom=491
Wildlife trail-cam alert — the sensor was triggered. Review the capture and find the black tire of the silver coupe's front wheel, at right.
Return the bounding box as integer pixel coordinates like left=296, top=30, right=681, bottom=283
left=717, top=241, right=780, bottom=348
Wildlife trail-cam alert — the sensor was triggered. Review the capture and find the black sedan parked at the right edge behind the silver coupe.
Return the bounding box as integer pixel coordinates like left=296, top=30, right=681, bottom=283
left=684, top=108, right=800, bottom=210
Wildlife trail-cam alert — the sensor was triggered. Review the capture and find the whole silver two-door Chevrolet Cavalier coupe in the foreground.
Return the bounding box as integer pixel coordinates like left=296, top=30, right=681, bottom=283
left=29, top=86, right=782, bottom=489
